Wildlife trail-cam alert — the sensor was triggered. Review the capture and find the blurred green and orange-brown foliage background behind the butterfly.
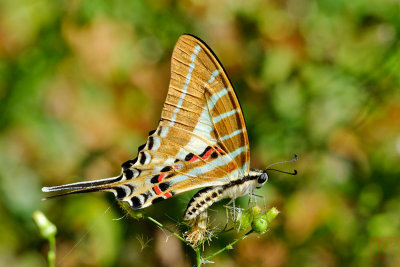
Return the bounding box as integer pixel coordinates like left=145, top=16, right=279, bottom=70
left=0, top=0, right=400, bottom=266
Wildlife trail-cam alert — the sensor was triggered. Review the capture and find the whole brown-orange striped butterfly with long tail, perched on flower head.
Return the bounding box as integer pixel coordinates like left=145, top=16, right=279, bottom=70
left=42, top=34, right=268, bottom=223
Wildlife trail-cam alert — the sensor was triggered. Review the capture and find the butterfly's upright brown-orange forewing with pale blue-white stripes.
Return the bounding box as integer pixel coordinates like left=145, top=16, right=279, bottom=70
left=160, top=35, right=250, bottom=176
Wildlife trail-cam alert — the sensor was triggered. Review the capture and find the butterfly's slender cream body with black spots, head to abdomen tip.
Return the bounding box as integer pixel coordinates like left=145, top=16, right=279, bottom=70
left=184, top=169, right=268, bottom=220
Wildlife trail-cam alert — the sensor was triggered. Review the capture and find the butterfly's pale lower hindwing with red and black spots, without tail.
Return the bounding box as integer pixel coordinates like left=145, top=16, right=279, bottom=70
left=118, top=125, right=236, bottom=209
